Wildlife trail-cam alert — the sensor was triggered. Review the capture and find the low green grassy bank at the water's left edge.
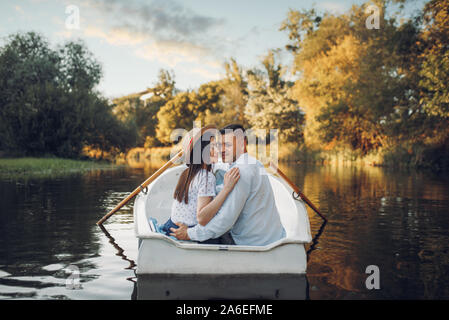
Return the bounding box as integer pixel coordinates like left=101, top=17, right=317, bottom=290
left=0, top=158, right=115, bottom=178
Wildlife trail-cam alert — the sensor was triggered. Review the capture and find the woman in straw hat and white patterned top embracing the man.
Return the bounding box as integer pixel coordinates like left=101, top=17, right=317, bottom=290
left=161, top=126, right=240, bottom=235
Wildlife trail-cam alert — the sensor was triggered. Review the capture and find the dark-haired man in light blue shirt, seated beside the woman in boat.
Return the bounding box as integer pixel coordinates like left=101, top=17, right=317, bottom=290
left=171, top=124, right=286, bottom=246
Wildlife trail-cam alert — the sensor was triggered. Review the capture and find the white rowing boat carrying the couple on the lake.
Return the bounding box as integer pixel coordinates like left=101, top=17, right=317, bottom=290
left=134, top=165, right=312, bottom=276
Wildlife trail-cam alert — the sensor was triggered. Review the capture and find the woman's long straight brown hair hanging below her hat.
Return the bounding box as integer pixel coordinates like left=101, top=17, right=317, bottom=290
left=173, top=139, right=211, bottom=204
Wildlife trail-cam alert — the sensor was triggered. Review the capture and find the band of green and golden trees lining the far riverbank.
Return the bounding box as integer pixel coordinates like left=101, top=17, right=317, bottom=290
left=0, top=0, right=449, bottom=170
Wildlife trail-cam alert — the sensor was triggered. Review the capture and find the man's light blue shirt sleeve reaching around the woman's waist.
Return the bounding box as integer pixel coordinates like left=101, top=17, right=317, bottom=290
left=187, top=170, right=251, bottom=241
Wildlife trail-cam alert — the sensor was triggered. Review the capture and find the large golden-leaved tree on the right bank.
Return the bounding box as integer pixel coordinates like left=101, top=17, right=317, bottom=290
left=283, top=0, right=428, bottom=155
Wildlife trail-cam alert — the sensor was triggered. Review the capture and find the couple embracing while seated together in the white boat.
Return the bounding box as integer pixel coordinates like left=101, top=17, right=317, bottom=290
left=161, top=124, right=286, bottom=246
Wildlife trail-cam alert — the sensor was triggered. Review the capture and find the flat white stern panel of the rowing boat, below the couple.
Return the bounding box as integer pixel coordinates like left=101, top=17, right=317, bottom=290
left=137, top=238, right=307, bottom=274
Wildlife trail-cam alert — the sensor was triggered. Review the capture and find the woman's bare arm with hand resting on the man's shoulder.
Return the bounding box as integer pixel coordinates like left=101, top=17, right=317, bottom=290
left=196, top=168, right=240, bottom=226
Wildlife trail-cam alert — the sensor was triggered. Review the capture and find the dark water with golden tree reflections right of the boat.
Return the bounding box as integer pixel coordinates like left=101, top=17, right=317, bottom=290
left=282, top=166, right=449, bottom=299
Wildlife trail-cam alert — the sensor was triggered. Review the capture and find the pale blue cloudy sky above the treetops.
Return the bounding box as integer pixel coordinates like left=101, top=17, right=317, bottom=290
left=0, top=0, right=425, bottom=98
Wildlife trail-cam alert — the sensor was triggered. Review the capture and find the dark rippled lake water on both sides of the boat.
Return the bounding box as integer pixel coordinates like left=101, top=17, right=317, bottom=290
left=0, top=164, right=449, bottom=299
